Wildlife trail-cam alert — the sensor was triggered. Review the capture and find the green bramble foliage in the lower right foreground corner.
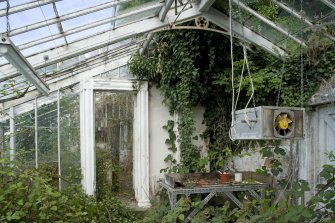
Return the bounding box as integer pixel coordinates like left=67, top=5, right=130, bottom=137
left=239, top=153, right=335, bottom=223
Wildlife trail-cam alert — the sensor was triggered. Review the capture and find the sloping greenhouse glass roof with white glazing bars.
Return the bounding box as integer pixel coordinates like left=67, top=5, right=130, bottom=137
left=0, top=0, right=335, bottom=103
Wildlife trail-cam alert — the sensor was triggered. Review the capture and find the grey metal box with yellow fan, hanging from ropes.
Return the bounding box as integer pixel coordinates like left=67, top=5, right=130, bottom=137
left=230, top=106, right=304, bottom=140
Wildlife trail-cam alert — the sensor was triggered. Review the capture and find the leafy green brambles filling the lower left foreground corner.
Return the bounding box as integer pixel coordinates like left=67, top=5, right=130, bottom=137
left=0, top=155, right=138, bottom=223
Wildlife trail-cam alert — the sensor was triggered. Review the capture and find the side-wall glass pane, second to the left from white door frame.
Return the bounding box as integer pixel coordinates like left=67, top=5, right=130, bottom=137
left=37, top=98, right=58, bottom=186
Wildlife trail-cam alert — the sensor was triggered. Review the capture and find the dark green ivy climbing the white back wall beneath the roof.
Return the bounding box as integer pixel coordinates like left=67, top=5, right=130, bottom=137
left=129, top=22, right=335, bottom=172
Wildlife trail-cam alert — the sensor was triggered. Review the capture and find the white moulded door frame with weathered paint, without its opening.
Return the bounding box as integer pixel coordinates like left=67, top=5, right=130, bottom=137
left=80, top=79, right=150, bottom=207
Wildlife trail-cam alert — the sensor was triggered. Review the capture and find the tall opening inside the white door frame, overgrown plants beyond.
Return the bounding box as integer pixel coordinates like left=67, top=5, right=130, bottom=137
left=95, top=91, right=134, bottom=199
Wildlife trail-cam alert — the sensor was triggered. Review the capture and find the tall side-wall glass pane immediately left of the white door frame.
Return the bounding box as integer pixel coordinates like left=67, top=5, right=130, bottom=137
left=59, top=89, right=81, bottom=188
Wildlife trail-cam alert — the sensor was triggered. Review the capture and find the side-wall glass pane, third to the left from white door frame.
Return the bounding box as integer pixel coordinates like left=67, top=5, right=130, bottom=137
left=15, top=108, right=36, bottom=167
